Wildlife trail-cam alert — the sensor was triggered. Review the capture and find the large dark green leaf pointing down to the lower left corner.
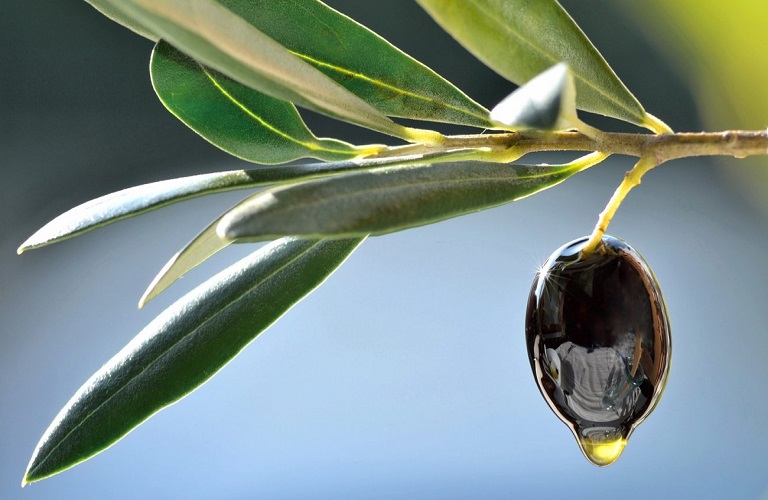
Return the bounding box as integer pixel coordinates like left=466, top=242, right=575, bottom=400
left=22, top=238, right=362, bottom=484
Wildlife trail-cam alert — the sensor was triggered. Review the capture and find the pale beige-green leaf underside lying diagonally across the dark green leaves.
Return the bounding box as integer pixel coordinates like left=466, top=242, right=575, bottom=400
left=111, top=0, right=442, bottom=142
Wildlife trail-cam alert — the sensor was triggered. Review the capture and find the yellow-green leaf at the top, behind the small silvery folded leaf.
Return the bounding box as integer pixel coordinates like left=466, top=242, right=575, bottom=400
left=417, top=0, right=659, bottom=131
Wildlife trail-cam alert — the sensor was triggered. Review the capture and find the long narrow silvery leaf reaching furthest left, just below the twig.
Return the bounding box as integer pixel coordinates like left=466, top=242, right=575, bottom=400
left=18, top=149, right=473, bottom=253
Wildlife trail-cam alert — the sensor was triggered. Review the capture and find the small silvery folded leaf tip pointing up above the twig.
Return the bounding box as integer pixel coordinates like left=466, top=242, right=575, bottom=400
left=491, top=63, right=578, bottom=130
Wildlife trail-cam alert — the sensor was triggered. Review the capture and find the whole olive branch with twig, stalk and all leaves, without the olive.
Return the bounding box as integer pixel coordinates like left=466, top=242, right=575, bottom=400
left=19, top=0, right=768, bottom=484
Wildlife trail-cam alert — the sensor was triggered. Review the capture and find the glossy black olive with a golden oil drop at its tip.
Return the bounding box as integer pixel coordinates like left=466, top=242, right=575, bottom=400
left=525, top=235, right=671, bottom=466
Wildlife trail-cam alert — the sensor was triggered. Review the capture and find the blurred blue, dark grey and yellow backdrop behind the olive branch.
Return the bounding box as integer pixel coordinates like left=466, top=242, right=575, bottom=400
left=0, top=0, right=768, bottom=499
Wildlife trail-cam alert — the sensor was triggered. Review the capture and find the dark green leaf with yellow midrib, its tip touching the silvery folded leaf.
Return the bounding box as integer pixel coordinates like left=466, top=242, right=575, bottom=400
left=216, top=0, right=491, bottom=128
